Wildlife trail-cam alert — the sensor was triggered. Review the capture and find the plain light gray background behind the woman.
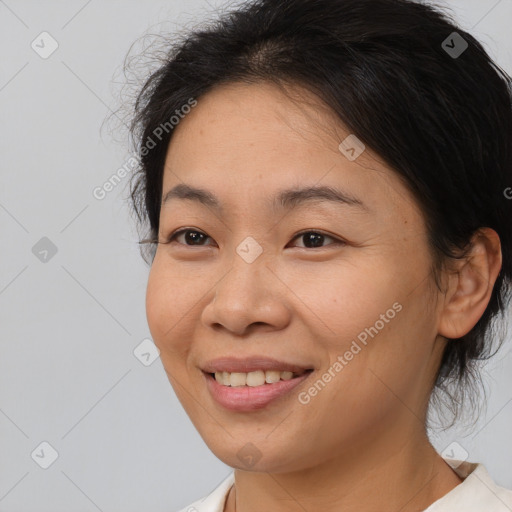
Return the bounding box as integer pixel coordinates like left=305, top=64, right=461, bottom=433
left=0, top=0, right=512, bottom=512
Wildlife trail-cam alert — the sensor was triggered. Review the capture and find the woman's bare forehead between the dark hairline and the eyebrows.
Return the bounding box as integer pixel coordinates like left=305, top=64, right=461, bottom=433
left=162, top=83, right=422, bottom=224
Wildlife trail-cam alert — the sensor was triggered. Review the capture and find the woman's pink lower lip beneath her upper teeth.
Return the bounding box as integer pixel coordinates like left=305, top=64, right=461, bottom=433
left=203, top=371, right=313, bottom=412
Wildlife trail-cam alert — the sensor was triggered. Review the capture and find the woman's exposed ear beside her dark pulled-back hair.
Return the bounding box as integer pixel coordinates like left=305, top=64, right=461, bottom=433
left=438, top=228, right=502, bottom=338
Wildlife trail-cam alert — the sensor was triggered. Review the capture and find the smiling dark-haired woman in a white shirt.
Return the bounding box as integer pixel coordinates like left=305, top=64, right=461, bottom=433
left=132, top=0, right=512, bottom=512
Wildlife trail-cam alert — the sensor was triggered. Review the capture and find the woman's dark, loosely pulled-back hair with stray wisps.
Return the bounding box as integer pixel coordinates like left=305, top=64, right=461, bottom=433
left=125, top=0, right=512, bottom=424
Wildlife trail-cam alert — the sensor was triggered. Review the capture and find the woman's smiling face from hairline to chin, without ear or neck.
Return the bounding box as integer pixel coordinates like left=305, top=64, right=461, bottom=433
left=146, top=84, right=443, bottom=472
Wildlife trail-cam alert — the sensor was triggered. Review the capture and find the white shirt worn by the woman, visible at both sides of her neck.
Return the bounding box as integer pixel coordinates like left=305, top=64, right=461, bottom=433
left=175, top=459, right=512, bottom=512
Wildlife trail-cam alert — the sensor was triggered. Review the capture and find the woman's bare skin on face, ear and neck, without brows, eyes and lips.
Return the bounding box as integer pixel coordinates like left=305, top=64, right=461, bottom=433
left=146, top=83, right=501, bottom=512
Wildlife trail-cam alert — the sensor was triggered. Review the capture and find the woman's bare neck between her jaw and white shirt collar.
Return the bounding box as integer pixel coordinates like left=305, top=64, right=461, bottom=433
left=225, top=426, right=462, bottom=512
